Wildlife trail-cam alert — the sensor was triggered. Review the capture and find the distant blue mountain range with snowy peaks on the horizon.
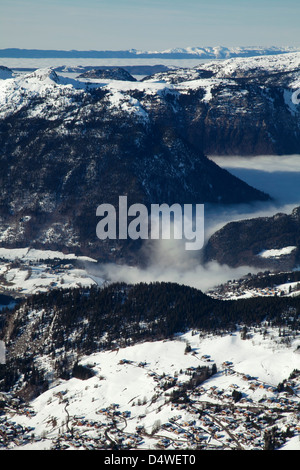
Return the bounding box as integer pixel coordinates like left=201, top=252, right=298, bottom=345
left=0, top=46, right=300, bottom=59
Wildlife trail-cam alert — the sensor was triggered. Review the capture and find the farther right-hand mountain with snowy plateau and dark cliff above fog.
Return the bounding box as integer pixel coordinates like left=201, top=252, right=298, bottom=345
left=146, top=53, right=300, bottom=156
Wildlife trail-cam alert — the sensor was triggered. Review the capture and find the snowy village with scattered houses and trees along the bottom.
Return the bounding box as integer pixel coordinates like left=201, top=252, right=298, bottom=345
left=0, top=342, right=300, bottom=450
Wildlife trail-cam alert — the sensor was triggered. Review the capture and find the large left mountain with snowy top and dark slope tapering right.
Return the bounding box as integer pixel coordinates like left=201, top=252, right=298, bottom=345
left=0, top=64, right=274, bottom=262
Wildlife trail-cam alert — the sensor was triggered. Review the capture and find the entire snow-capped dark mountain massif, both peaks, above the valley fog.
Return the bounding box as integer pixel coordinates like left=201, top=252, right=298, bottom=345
left=0, top=52, right=300, bottom=263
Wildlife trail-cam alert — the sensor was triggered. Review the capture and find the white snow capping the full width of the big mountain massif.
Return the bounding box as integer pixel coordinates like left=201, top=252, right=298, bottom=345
left=0, top=52, right=300, bottom=120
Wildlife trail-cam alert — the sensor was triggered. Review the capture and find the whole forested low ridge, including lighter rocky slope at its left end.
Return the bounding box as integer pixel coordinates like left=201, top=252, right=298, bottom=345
left=2, top=283, right=300, bottom=400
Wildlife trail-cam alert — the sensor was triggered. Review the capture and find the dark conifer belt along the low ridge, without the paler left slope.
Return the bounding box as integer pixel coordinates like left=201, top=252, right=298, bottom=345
left=1, top=282, right=300, bottom=352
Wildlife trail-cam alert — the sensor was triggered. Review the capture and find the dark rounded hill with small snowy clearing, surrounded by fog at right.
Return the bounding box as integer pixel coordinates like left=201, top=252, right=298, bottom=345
left=205, top=207, right=300, bottom=271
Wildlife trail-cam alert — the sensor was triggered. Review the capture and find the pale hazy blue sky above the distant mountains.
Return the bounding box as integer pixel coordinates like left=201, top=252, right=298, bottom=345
left=0, top=0, right=300, bottom=50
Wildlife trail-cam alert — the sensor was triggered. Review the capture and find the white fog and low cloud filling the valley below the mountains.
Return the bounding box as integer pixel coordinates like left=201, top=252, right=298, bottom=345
left=88, top=155, right=300, bottom=291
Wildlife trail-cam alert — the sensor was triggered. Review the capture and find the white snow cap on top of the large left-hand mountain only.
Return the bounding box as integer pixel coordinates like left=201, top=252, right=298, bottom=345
left=0, top=67, right=173, bottom=120
